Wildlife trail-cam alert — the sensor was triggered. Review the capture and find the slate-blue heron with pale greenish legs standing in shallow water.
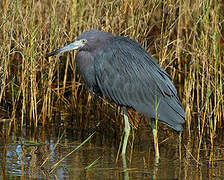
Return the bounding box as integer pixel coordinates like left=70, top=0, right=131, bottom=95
left=45, top=30, right=186, bottom=162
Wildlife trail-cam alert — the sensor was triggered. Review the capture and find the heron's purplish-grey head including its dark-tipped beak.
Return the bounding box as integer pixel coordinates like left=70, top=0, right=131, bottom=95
left=46, top=30, right=114, bottom=58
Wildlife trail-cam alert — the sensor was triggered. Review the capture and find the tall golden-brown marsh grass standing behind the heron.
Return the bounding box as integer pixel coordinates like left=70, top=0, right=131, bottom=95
left=0, top=0, right=224, bottom=165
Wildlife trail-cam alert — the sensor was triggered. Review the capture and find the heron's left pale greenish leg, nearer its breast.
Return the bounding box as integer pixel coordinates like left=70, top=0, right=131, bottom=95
left=121, top=107, right=130, bottom=155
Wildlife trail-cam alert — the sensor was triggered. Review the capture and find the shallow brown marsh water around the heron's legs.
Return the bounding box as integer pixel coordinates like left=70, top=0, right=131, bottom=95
left=0, top=117, right=224, bottom=180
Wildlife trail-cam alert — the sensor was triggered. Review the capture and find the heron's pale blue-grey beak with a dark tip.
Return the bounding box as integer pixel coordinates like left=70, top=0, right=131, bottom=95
left=45, top=40, right=85, bottom=58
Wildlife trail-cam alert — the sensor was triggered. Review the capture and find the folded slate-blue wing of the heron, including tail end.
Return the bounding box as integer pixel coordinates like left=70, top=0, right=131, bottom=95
left=94, top=37, right=185, bottom=131
